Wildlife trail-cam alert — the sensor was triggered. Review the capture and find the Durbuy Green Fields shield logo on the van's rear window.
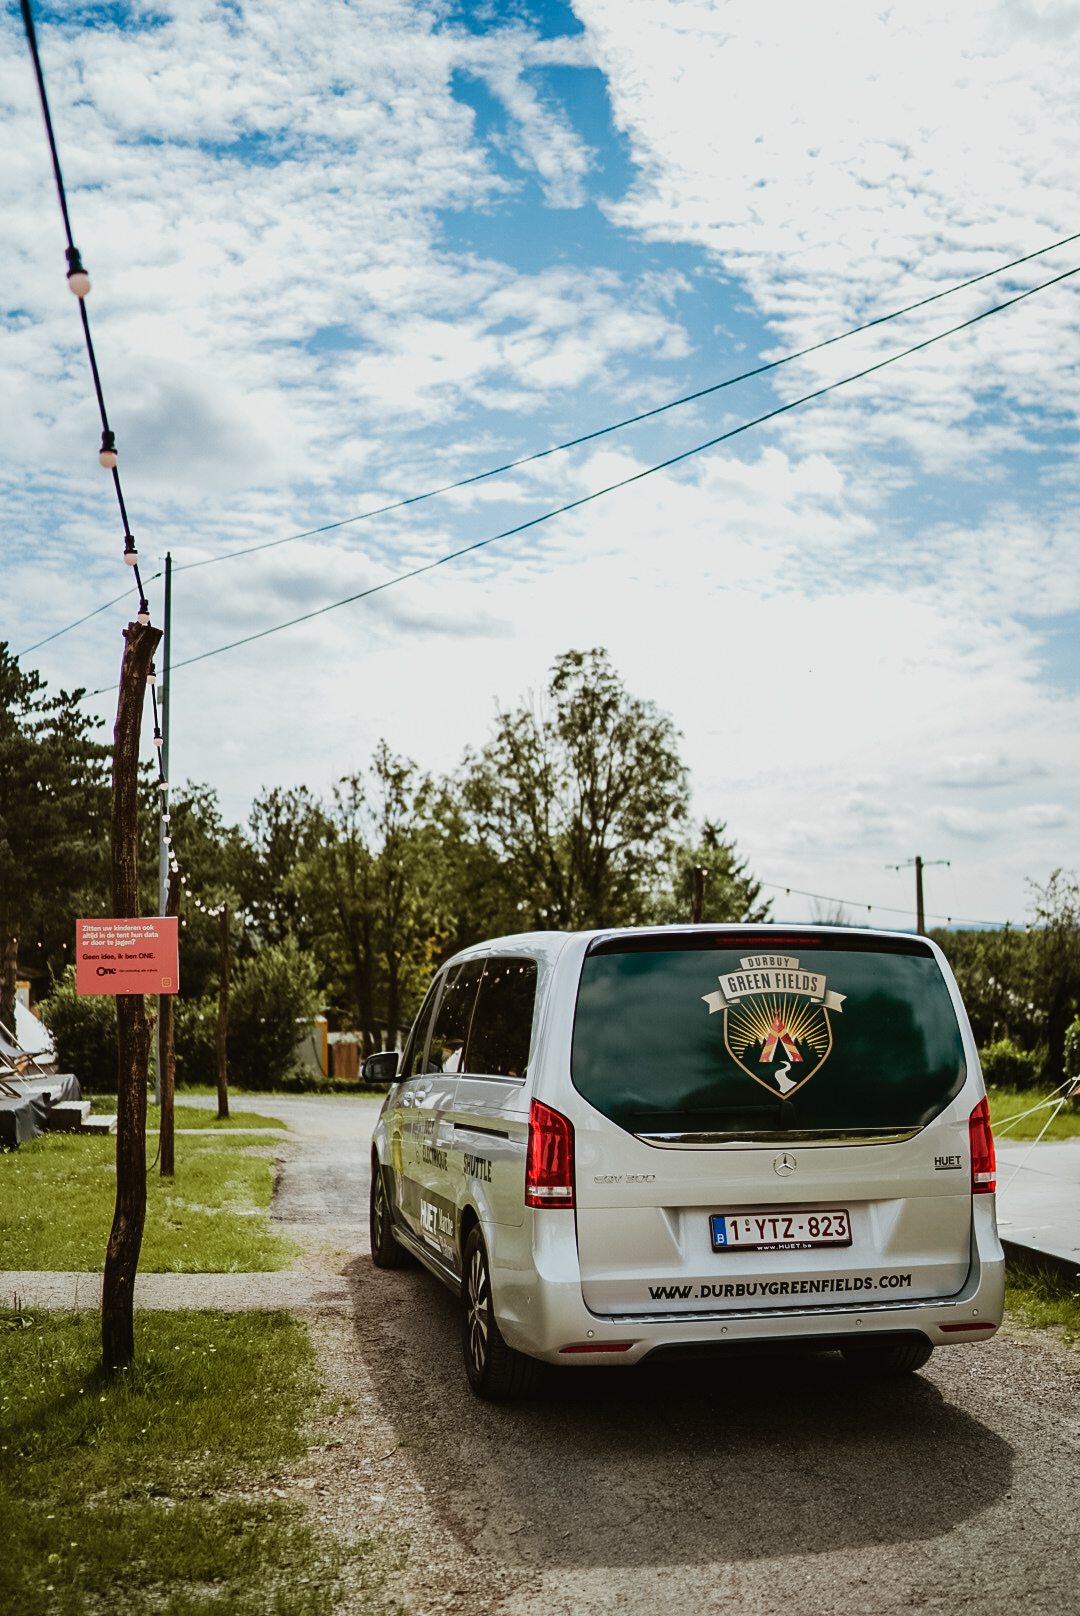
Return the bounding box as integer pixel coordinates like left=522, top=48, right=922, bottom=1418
left=702, top=953, right=847, bottom=1097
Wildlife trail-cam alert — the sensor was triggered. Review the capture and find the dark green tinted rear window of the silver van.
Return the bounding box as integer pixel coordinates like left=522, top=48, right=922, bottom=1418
left=572, top=932, right=965, bottom=1139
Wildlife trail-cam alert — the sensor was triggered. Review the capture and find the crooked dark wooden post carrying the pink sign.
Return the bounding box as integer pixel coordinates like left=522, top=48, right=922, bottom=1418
left=102, top=610, right=162, bottom=1370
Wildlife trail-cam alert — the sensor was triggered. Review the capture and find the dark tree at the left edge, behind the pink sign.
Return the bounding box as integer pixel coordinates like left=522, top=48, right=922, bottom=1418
left=0, top=642, right=112, bottom=1026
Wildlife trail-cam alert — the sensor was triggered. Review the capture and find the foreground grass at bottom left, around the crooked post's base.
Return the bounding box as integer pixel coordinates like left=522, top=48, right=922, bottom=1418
left=0, top=1312, right=380, bottom=1616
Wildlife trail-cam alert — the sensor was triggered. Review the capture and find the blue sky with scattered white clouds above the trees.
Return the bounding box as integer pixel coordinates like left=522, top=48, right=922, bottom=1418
left=0, top=0, right=1080, bottom=928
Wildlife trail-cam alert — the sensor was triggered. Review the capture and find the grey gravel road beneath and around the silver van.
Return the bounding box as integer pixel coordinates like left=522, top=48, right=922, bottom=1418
left=227, top=1097, right=1080, bottom=1616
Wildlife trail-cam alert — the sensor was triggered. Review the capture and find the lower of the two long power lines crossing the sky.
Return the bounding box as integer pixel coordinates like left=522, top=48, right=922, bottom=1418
left=107, top=255, right=1080, bottom=695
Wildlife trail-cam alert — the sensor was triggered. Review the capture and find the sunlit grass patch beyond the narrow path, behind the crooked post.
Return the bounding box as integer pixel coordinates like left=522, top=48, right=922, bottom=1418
left=0, top=1133, right=297, bottom=1273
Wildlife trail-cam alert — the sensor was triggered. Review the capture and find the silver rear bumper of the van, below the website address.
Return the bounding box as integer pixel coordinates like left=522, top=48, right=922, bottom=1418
left=495, top=1196, right=1006, bottom=1366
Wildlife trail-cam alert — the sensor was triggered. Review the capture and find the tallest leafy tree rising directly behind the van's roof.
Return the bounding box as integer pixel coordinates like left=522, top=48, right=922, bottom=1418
left=456, top=648, right=687, bottom=931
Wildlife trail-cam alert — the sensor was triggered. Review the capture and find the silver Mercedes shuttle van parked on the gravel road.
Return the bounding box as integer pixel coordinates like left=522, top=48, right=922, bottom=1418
left=372, top=926, right=1004, bottom=1398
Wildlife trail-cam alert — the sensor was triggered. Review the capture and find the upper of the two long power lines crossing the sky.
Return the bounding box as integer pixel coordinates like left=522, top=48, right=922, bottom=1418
left=19, top=231, right=1080, bottom=656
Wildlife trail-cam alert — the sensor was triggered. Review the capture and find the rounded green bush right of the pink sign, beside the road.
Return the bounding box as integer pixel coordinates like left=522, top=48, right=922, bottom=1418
left=226, top=936, right=319, bottom=1089
